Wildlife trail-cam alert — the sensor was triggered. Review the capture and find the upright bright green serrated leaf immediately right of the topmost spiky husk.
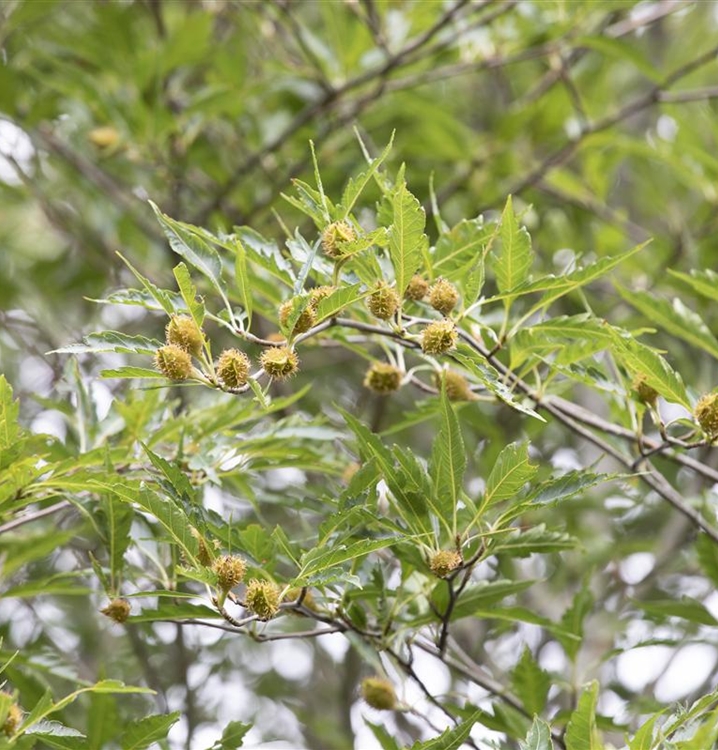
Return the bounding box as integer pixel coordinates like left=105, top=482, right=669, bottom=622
left=389, top=180, right=427, bottom=297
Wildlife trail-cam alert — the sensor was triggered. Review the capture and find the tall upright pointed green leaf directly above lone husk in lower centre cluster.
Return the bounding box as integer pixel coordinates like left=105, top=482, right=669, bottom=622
left=431, top=388, right=466, bottom=533
